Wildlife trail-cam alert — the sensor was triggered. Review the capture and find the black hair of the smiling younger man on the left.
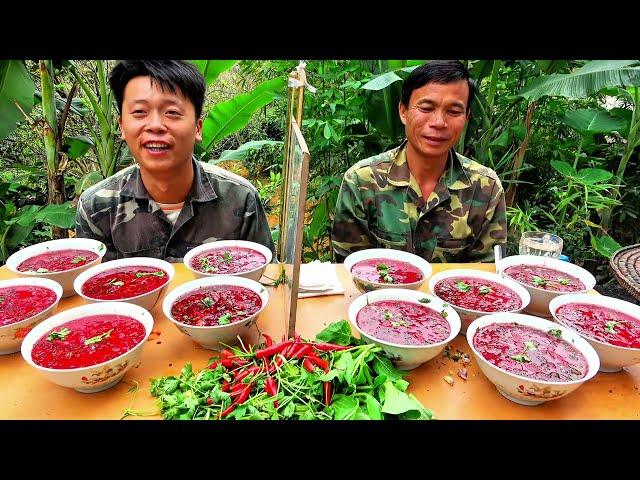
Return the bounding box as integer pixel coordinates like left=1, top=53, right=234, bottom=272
left=109, top=60, right=207, bottom=119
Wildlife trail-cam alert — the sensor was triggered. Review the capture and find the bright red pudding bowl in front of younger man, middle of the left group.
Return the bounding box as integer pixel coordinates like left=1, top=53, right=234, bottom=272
left=73, top=257, right=175, bottom=310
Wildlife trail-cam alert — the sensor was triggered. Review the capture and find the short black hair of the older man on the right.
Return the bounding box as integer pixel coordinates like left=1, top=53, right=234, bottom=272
left=401, top=60, right=476, bottom=113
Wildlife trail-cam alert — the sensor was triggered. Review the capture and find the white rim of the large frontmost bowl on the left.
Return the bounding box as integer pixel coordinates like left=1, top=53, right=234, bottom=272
left=20, top=302, right=154, bottom=373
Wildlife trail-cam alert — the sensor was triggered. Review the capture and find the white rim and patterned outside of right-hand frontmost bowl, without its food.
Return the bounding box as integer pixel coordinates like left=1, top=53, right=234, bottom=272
left=467, top=313, right=600, bottom=406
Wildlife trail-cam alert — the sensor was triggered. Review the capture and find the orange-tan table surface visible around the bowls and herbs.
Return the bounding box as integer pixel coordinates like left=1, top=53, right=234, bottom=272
left=0, top=264, right=640, bottom=419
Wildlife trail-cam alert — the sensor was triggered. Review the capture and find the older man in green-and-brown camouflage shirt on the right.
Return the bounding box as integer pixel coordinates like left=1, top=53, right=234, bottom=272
left=331, top=60, right=507, bottom=262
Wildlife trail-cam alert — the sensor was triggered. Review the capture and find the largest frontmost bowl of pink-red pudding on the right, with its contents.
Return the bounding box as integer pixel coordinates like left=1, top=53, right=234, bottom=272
left=467, top=313, right=600, bottom=406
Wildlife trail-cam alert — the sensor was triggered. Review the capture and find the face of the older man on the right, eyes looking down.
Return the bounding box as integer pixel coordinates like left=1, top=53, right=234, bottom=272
left=399, top=80, right=469, bottom=159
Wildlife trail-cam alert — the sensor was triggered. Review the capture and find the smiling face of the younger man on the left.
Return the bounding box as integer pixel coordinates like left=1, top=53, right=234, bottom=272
left=120, top=77, right=202, bottom=175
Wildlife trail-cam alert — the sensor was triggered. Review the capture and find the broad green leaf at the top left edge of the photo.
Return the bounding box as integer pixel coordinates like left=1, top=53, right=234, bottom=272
left=0, top=60, right=35, bottom=140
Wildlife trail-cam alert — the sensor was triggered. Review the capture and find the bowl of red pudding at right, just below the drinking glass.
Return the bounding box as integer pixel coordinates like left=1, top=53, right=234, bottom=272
left=496, top=255, right=596, bottom=318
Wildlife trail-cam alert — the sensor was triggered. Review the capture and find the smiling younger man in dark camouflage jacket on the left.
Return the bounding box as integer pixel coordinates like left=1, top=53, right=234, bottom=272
left=76, top=60, right=274, bottom=262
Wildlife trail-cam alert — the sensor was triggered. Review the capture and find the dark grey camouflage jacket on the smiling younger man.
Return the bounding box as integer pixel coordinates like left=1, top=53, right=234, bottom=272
left=76, top=159, right=274, bottom=262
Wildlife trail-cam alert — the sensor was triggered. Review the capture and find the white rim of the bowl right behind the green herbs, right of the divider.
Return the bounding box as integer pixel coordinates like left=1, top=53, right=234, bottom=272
left=349, top=288, right=462, bottom=350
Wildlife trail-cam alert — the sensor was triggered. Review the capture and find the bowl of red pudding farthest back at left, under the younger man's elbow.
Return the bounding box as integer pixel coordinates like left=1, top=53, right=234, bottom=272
left=7, top=238, right=107, bottom=298
